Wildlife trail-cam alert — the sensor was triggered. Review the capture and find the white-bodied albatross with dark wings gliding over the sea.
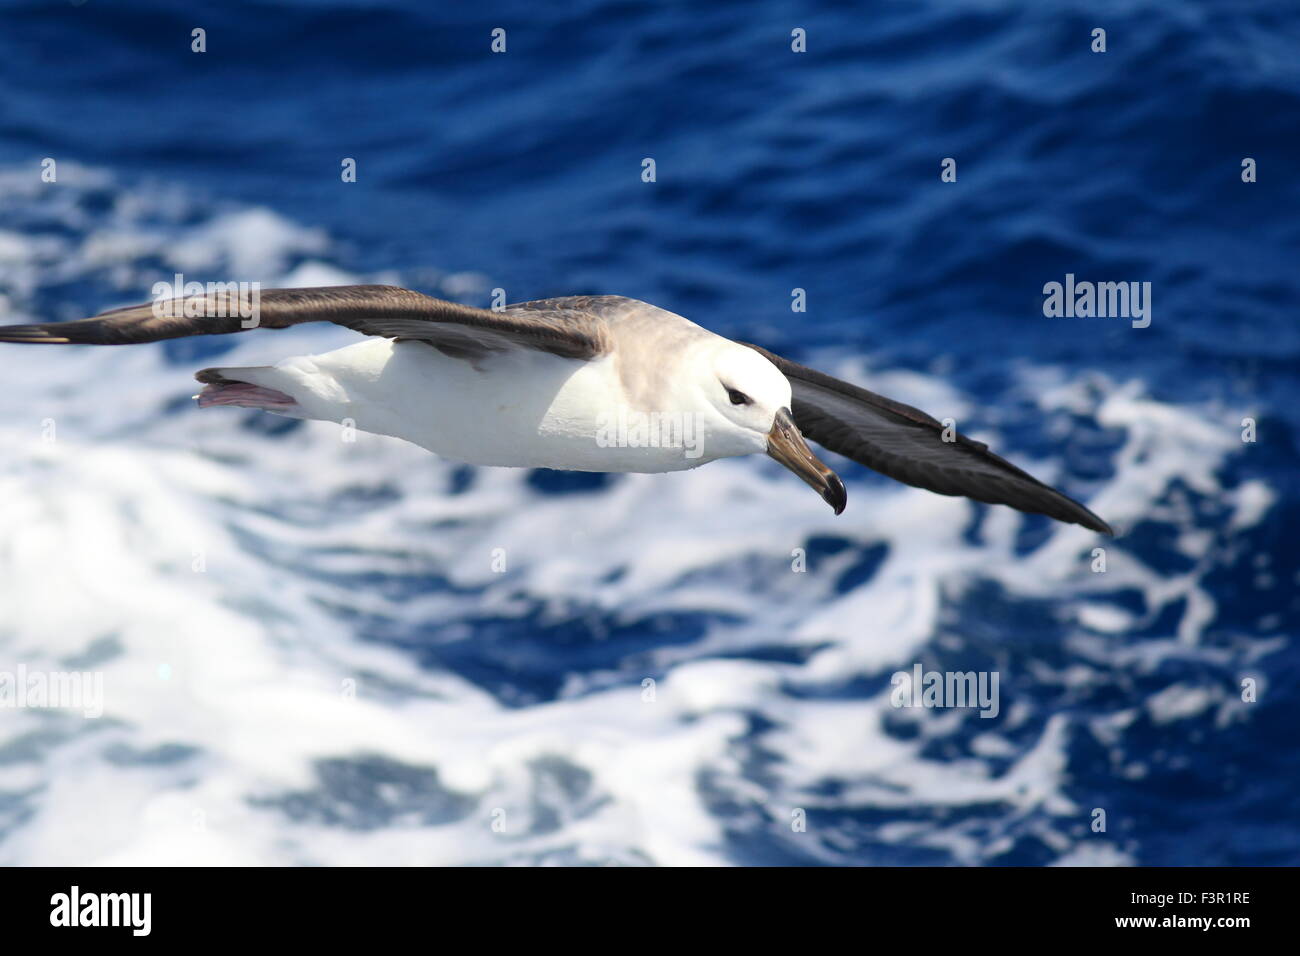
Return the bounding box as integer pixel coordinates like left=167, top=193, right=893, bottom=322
left=0, top=285, right=1113, bottom=535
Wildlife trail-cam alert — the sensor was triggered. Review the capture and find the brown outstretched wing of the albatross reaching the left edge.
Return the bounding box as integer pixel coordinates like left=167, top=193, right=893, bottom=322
left=0, top=285, right=607, bottom=359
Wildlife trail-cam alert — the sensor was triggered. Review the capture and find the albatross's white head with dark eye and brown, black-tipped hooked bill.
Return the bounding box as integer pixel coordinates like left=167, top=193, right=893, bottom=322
left=701, top=342, right=848, bottom=514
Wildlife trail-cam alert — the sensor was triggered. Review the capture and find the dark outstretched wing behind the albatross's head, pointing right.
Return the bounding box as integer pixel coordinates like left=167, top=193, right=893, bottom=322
left=742, top=342, right=1114, bottom=535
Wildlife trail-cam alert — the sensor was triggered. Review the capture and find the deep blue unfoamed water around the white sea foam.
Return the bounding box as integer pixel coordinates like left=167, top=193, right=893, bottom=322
left=0, top=0, right=1300, bottom=865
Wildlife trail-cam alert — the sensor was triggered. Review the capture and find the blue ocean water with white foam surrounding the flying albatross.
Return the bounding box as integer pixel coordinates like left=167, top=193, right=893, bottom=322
left=0, top=0, right=1300, bottom=865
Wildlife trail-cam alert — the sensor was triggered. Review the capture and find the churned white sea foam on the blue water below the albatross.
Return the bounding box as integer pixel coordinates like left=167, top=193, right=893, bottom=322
left=0, top=170, right=1271, bottom=865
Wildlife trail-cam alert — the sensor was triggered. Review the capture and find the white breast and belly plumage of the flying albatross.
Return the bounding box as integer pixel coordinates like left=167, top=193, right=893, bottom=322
left=277, top=338, right=720, bottom=472
